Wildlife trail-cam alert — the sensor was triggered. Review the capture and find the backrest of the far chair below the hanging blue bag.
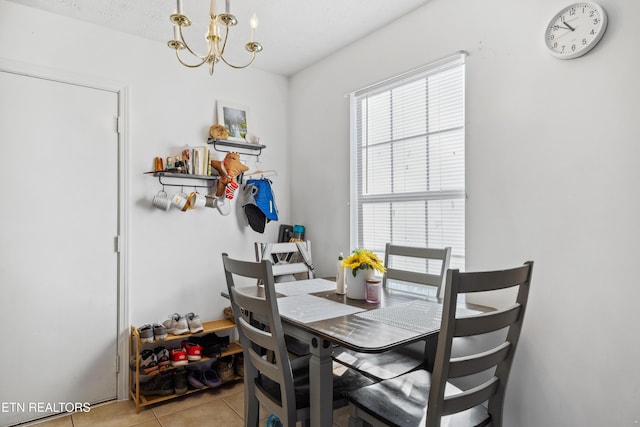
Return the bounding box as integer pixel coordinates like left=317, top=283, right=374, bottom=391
left=255, top=240, right=314, bottom=282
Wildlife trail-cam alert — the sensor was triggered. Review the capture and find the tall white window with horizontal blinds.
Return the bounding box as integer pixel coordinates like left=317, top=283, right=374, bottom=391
left=351, top=54, right=465, bottom=273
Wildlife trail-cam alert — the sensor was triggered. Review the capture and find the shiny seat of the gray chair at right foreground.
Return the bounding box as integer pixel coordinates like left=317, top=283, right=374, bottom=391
left=349, top=369, right=488, bottom=427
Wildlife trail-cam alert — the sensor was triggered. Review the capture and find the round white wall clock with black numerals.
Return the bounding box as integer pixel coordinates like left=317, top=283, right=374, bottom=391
left=545, top=3, right=607, bottom=59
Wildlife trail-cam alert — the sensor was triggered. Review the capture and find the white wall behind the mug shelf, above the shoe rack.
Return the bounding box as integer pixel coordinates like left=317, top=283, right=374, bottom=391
left=0, top=1, right=290, bottom=328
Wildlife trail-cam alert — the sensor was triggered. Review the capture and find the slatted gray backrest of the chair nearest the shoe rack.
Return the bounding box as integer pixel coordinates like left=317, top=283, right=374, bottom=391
left=222, top=253, right=296, bottom=425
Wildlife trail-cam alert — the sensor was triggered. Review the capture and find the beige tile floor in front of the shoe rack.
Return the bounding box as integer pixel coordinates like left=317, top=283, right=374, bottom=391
left=23, top=383, right=349, bottom=427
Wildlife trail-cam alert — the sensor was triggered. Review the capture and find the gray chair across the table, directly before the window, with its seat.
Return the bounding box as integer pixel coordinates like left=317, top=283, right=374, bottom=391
left=334, top=243, right=451, bottom=381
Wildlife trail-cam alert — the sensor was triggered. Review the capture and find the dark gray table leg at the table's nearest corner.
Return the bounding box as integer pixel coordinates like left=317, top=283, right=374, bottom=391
left=309, top=337, right=333, bottom=427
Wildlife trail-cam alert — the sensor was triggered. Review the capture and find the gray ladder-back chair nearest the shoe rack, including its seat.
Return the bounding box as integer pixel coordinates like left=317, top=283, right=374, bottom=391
left=222, top=253, right=373, bottom=427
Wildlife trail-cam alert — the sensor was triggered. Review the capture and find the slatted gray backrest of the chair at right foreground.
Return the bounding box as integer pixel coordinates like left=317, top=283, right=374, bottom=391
left=427, top=261, right=533, bottom=427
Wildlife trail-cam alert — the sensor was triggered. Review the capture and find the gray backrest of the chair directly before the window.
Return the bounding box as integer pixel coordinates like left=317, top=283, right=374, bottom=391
left=382, top=243, right=451, bottom=297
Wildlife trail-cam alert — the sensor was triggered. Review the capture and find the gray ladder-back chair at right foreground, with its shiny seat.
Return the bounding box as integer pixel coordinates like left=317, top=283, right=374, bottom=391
left=349, top=261, right=533, bottom=427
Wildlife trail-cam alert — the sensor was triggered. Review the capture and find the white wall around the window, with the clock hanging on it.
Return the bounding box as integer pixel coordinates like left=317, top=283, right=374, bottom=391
left=289, top=0, right=640, bottom=427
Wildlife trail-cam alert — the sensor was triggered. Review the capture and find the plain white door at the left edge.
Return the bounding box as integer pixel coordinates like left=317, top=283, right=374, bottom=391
left=0, top=71, right=118, bottom=426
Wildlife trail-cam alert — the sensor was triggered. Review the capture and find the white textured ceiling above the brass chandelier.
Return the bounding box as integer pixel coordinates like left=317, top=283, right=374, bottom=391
left=9, top=0, right=429, bottom=76
